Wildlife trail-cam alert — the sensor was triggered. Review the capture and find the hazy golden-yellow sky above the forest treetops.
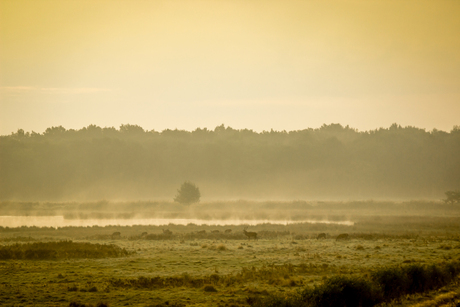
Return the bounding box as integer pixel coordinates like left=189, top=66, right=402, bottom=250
left=0, top=0, right=460, bottom=134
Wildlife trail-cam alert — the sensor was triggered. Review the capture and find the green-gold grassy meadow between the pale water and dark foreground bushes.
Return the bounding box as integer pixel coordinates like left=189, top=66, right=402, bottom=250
left=0, top=201, right=460, bottom=306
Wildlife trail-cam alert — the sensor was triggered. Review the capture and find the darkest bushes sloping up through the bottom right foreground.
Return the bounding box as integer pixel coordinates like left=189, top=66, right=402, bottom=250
left=250, top=262, right=460, bottom=307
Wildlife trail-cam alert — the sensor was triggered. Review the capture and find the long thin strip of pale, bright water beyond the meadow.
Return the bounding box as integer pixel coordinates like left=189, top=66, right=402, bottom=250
left=0, top=216, right=354, bottom=227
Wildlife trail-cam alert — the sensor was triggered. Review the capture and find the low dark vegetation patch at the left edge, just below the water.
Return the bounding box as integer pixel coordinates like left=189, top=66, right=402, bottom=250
left=0, top=240, right=129, bottom=260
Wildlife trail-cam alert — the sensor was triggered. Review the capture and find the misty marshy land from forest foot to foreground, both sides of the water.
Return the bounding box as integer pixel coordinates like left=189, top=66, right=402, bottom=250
left=0, top=202, right=460, bottom=306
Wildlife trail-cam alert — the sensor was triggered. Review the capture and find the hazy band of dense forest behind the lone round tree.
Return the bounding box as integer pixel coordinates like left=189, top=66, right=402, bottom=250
left=0, top=124, right=460, bottom=201
